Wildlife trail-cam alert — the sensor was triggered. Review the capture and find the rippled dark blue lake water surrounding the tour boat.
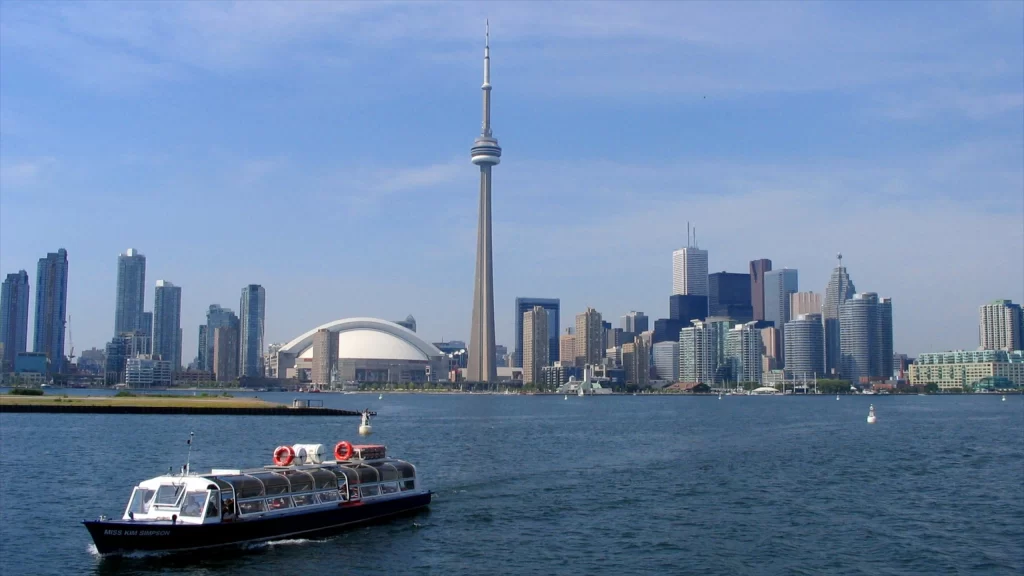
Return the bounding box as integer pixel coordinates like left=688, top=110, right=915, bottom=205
left=0, top=394, right=1024, bottom=576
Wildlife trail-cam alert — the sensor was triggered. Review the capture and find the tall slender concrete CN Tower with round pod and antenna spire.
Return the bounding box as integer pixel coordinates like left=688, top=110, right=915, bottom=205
left=467, top=23, right=502, bottom=382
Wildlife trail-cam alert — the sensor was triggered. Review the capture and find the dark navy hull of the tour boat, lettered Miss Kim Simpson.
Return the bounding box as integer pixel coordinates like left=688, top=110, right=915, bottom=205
left=83, top=491, right=431, bottom=556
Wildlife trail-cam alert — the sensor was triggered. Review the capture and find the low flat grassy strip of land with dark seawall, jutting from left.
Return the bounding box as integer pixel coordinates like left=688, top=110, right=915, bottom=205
left=0, top=395, right=360, bottom=416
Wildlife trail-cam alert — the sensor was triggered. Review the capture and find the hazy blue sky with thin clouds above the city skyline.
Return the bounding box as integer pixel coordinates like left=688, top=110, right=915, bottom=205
left=0, top=1, right=1024, bottom=362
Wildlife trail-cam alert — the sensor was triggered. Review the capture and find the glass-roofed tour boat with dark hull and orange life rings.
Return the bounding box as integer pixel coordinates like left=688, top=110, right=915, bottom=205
left=83, top=439, right=432, bottom=554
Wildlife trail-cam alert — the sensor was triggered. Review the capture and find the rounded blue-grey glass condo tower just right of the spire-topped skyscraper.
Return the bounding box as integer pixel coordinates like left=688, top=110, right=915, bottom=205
left=840, top=292, right=893, bottom=383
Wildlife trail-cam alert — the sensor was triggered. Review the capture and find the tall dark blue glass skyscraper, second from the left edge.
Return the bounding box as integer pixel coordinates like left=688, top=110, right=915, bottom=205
left=32, top=248, right=68, bottom=374
